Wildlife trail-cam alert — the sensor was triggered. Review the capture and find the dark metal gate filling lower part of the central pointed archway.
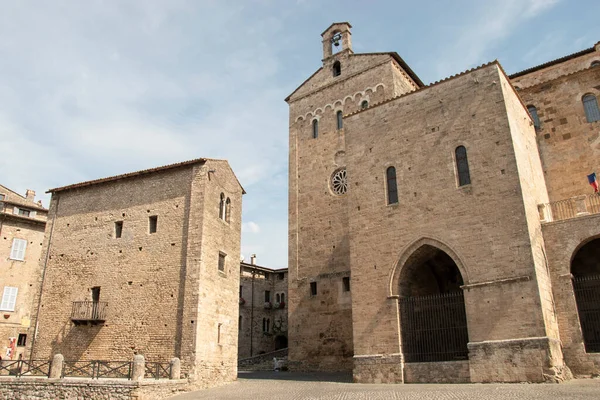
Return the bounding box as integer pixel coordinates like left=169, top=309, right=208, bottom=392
left=400, top=292, right=469, bottom=363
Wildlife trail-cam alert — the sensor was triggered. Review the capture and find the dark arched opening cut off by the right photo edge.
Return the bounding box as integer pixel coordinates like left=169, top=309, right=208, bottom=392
left=571, top=238, right=600, bottom=353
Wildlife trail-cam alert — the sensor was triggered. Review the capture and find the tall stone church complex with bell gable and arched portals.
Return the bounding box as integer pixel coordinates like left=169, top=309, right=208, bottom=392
left=286, top=23, right=600, bottom=382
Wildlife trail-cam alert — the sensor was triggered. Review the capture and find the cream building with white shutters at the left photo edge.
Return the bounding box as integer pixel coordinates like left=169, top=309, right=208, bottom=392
left=0, top=185, right=48, bottom=360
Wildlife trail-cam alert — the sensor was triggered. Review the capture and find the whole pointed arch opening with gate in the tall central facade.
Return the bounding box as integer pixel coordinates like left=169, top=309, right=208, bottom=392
left=398, top=244, right=469, bottom=363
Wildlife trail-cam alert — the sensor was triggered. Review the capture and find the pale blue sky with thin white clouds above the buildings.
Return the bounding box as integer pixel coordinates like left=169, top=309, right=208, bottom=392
left=0, top=0, right=600, bottom=268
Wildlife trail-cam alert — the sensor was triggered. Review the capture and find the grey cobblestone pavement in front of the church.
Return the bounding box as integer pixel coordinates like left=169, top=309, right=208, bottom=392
left=171, top=372, right=600, bottom=400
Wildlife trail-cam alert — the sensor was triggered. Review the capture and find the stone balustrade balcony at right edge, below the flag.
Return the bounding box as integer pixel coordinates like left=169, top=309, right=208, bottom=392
left=538, top=193, right=600, bottom=223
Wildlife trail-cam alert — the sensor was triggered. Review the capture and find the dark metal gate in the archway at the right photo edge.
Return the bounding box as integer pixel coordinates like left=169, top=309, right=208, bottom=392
left=573, top=275, right=600, bottom=353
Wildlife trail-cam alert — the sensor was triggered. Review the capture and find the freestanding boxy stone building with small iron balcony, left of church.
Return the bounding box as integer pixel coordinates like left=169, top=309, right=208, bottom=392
left=33, top=158, right=244, bottom=384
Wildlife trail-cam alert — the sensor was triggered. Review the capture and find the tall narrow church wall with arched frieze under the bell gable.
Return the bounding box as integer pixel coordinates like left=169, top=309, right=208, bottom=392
left=287, top=27, right=415, bottom=370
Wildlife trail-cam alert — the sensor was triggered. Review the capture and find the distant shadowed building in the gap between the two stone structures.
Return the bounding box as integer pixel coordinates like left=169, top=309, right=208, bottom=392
left=238, top=255, right=288, bottom=359
